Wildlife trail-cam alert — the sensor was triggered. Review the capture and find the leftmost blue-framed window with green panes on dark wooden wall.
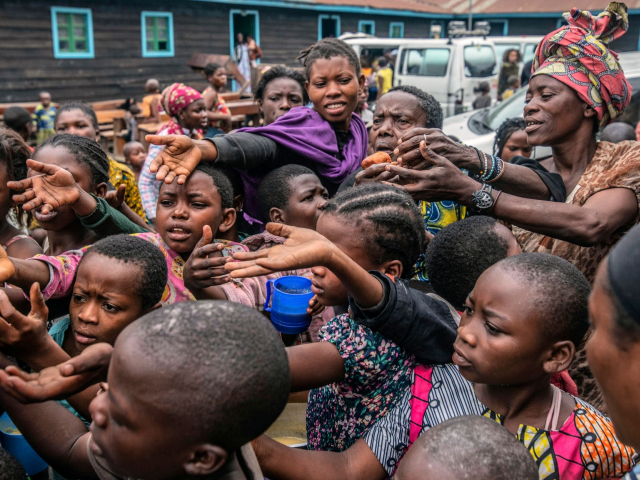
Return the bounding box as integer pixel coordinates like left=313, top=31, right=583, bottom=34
left=51, top=7, right=95, bottom=58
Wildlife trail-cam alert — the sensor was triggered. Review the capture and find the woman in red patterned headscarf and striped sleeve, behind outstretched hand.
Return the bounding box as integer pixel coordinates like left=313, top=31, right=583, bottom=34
left=138, top=83, right=207, bottom=221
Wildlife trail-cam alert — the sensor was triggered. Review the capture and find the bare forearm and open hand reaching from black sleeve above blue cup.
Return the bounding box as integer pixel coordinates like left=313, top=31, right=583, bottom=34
left=225, top=223, right=384, bottom=308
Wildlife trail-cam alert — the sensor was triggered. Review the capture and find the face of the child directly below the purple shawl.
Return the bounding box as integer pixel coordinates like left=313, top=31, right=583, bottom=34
left=272, top=174, right=329, bottom=230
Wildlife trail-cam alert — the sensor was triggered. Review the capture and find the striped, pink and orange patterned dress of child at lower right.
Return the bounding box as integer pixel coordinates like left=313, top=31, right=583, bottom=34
left=364, top=365, right=636, bottom=480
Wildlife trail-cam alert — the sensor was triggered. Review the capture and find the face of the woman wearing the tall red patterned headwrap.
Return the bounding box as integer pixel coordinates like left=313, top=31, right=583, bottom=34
left=524, top=75, right=596, bottom=147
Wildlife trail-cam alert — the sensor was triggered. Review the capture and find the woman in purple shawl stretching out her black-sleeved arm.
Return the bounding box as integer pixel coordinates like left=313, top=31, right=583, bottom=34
left=147, top=38, right=367, bottom=222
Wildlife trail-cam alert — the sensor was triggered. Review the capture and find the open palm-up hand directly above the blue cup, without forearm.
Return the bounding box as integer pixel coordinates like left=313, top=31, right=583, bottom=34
left=225, top=223, right=336, bottom=278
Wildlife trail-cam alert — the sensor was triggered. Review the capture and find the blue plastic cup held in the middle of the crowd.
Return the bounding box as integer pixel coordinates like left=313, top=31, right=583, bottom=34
left=264, top=275, right=313, bottom=335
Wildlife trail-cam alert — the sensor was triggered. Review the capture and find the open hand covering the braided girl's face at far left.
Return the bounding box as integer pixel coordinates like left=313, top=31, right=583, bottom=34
left=7, top=160, right=80, bottom=215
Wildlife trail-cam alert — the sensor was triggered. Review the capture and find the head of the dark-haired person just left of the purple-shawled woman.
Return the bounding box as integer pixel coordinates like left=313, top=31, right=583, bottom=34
left=253, top=65, right=309, bottom=126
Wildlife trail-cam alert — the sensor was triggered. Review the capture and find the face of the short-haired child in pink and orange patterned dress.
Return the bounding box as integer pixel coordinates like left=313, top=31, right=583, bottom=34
left=453, top=265, right=550, bottom=385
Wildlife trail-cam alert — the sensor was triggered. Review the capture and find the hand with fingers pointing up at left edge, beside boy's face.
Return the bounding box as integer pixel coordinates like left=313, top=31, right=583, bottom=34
left=0, top=283, right=49, bottom=358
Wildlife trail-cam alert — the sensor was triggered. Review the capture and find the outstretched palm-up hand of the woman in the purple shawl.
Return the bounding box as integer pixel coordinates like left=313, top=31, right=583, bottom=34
left=145, top=135, right=202, bottom=184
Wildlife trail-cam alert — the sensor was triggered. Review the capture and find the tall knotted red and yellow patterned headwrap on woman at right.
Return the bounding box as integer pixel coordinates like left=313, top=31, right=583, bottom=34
left=531, top=2, right=631, bottom=128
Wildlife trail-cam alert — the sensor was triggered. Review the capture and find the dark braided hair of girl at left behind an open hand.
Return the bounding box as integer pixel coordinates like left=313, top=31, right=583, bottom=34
left=36, top=135, right=109, bottom=188
